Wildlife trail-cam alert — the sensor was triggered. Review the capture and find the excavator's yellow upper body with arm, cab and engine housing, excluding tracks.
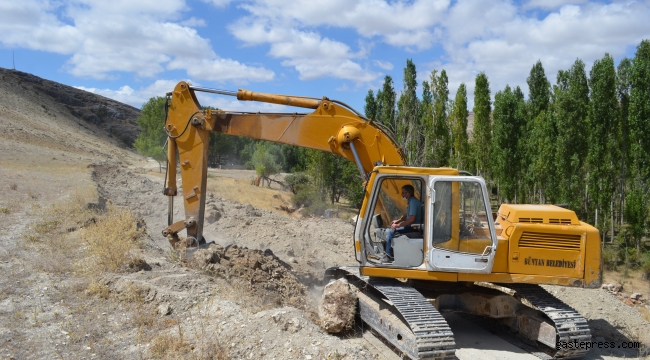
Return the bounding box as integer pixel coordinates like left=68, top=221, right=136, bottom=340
left=163, top=82, right=602, bottom=287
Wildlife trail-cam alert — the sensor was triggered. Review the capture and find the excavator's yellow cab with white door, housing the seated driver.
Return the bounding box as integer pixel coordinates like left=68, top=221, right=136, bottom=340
left=358, top=168, right=497, bottom=273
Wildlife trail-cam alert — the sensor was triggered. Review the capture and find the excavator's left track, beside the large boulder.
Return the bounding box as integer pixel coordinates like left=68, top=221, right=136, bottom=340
left=326, top=267, right=456, bottom=359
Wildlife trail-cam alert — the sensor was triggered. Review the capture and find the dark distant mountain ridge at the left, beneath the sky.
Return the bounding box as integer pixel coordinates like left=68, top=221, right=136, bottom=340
left=0, top=67, right=140, bottom=147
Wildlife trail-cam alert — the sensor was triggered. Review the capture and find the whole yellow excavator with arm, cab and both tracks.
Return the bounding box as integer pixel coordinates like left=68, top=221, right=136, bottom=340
left=163, top=82, right=602, bottom=359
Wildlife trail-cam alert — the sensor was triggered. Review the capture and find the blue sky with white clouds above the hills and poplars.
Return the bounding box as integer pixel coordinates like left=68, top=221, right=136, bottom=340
left=0, top=0, right=650, bottom=111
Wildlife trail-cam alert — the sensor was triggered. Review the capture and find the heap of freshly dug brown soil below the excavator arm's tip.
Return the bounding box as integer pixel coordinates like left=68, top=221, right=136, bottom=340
left=190, top=244, right=307, bottom=308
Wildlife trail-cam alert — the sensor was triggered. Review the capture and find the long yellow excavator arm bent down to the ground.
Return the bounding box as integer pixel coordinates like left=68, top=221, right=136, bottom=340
left=163, top=82, right=406, bottom=245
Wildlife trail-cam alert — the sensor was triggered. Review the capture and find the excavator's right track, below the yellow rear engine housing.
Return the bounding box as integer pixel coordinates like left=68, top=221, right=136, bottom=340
left=501, top=284, right=591, bottom=359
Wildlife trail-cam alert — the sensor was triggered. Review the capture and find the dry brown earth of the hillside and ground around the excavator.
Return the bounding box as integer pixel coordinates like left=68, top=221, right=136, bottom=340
left=0, top=71, right=650, bottom=359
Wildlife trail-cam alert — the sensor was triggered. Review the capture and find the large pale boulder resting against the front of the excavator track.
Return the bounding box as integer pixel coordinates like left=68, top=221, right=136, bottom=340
left=318, top=279, right=357, bottom=334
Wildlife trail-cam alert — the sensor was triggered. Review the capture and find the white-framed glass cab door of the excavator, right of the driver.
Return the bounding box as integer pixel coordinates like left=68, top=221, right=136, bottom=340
left=426, top=176, right=497, bottom=274
